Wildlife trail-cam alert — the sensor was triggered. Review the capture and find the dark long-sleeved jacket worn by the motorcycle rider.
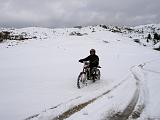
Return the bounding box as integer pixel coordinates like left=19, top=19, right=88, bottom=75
left=79, top=55, right=99, bottom=67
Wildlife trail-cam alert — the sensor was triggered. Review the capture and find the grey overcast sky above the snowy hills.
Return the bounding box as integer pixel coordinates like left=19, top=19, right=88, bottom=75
left=0, top=0, right=160, bottom=28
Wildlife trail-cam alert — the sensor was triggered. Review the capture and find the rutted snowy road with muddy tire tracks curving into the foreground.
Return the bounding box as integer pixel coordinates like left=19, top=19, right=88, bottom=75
left=26, top=66, right=149, bottom=120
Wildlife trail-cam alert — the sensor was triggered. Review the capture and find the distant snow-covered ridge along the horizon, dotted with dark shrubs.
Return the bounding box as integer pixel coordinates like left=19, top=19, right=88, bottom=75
left=0, top=24, right=160, bottom=49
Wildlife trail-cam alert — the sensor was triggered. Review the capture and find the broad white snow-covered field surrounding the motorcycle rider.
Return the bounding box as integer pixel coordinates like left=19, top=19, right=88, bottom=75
left=0, top=24, right=160, bottom=120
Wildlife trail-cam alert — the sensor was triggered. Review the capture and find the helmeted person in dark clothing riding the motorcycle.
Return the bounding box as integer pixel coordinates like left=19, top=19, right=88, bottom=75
left=79, top=49, right=99, bottom=79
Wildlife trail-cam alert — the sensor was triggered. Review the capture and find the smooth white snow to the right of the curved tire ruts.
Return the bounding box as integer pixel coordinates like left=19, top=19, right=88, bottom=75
left=138, top=59, right=160, bottom=119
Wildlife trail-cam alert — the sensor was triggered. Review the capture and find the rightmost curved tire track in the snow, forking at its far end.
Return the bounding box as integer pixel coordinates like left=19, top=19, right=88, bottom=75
left=109, top=59, right=160, bottom=120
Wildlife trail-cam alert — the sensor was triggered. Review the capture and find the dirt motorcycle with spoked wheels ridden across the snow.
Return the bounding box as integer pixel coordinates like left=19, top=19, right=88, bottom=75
left=77, top=61, right=101, bottom=89
